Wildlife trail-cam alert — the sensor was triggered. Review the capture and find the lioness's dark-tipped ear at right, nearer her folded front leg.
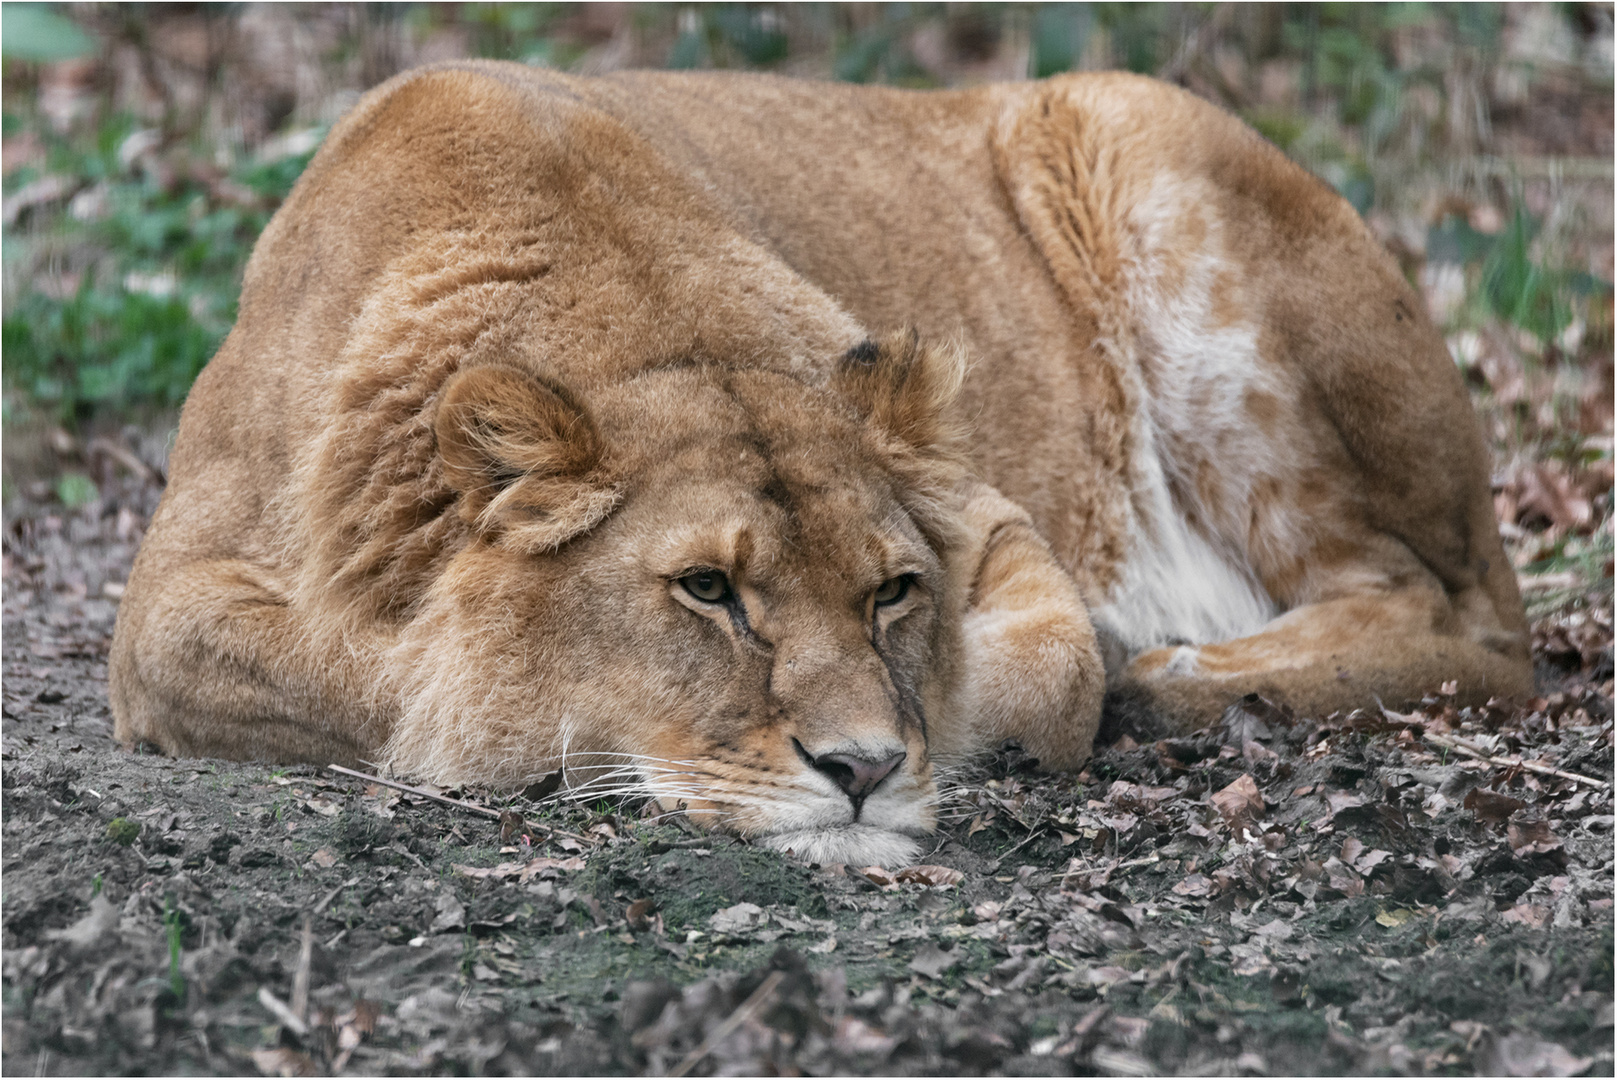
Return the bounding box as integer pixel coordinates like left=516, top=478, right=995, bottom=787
left=831, top=330, right=965, bottom=451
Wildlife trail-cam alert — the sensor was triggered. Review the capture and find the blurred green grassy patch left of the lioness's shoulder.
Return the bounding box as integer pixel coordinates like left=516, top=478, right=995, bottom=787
left=0, top=109, right=312, bottom=420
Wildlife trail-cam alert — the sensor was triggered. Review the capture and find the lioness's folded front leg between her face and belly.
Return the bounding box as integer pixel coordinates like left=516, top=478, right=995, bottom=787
left=939, top=485, right=1104, bottom=770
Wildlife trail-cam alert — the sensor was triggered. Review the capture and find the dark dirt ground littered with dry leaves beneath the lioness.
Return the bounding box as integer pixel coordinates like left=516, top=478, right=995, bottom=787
left=0, top=445, right=1614, bottom=1075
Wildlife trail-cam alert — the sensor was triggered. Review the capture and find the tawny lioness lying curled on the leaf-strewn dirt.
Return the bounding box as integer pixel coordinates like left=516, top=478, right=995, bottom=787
left=110, top=63, right=1531, bottom=863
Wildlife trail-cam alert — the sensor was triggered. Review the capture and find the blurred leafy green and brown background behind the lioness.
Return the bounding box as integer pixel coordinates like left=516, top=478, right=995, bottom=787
left=0, top=3, right=1612, bottom=607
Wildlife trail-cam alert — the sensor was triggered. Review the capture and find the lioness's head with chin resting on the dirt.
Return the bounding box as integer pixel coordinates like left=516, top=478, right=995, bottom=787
left=388, top=333, right=959, bottom=863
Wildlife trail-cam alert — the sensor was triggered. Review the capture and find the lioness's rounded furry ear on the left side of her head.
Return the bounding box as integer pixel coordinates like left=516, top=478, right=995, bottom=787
left=435, top=365, right=618, bottom=551
